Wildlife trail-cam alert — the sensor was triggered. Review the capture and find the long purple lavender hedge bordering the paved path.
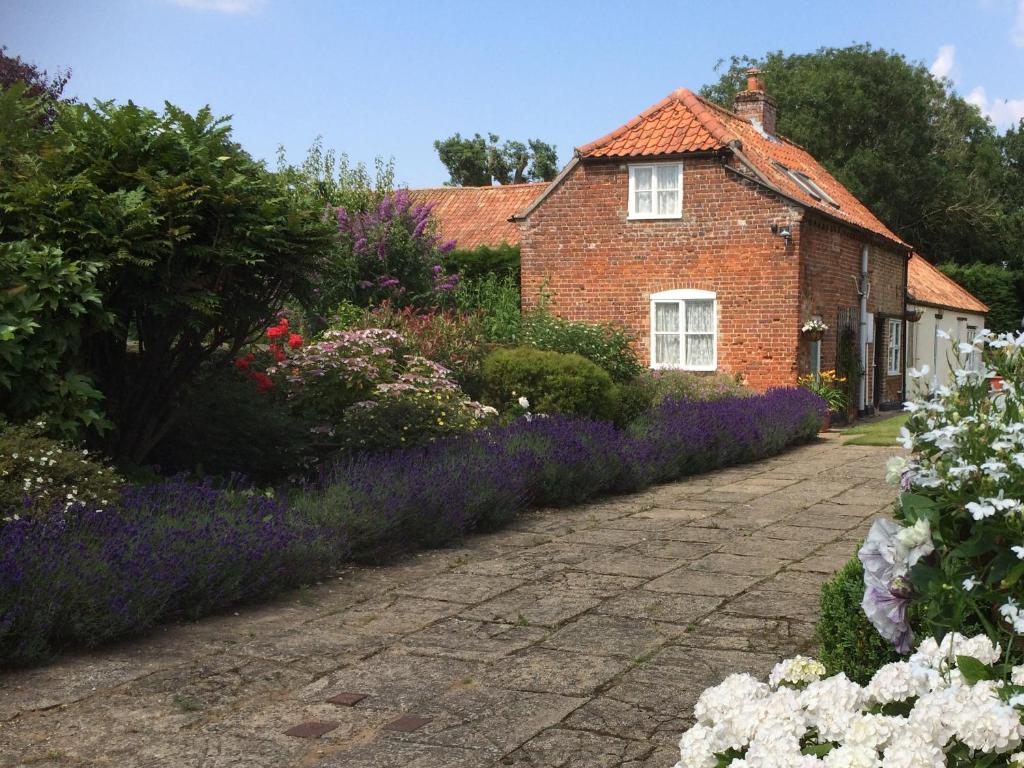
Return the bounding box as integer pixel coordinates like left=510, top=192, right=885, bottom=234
left=0, top=389, right=823, bottom=666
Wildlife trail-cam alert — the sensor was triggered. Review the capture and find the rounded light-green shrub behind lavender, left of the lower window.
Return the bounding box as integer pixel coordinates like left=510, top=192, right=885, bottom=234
left=483, top=347, right=616, bottom=419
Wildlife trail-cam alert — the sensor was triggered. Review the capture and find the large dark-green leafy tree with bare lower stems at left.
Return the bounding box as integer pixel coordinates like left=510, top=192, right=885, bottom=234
left=0, top=96, right=336, bottom=463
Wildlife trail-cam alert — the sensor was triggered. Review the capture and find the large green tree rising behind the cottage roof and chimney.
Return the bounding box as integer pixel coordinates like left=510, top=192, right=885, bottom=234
left=702, top=45, right=1007, bottom=263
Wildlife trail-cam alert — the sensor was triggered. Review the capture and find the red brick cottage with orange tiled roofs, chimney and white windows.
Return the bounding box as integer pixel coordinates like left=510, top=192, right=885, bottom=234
left=415, top=71, right=910, bottom=413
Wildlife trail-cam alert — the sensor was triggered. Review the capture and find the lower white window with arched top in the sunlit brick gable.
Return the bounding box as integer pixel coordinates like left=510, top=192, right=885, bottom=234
left=650, top=289, right=718, bottom=371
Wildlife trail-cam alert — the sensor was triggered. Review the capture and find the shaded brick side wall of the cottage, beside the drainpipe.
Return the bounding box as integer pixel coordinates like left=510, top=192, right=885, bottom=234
left=800, top=213, right=906, bottom=404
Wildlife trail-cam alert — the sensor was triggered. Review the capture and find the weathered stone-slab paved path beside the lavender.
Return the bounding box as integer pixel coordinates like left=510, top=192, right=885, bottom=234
left=0, top=436, right=894, bottom=768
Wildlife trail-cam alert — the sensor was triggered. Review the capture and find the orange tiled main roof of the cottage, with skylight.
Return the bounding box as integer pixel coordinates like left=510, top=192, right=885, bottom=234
left=577, top=88, right=906, bottom=247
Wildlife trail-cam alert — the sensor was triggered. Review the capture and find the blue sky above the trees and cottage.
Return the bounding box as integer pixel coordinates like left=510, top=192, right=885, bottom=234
left=0, top=0, right=1024, bottom=186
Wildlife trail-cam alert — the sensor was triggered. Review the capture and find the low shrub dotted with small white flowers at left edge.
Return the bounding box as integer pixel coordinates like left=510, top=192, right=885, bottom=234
left=0, top=422, right=124, bottom=520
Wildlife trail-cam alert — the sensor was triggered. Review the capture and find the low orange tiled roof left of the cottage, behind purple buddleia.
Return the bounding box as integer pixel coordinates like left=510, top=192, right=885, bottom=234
left=409, top=181, right=548, bottom=248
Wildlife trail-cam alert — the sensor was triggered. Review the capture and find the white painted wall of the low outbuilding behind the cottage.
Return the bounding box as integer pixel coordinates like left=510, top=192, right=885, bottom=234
left=906, top=303, right=985, bottom=396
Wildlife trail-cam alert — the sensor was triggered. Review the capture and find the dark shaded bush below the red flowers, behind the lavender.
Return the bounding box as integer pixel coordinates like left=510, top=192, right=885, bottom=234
left=150, top=355, right=311, bottom=482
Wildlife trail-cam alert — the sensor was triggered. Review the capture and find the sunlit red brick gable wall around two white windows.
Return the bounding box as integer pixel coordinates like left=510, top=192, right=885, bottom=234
left=521, top=158, right=800, bottom=389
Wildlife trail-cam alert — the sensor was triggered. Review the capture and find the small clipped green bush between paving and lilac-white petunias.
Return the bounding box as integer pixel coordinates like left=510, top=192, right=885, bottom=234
left=816, top=557, right=900, bottom=685
